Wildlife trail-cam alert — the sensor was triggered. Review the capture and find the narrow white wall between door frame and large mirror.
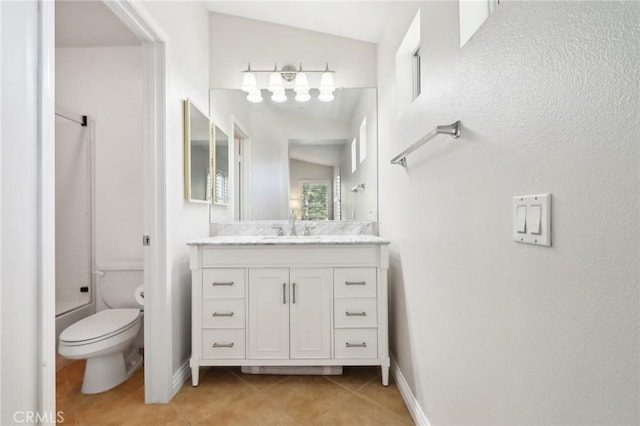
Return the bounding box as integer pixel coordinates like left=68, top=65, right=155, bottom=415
left=143, top=1, right=209, bottom=379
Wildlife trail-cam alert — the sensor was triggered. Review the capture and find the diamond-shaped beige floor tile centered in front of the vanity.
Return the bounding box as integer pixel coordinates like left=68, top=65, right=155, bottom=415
left=263, top=376, right=350, bottom=422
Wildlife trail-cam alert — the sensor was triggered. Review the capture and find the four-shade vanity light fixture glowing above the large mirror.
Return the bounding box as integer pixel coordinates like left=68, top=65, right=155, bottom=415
left=241, top=63, right=335, bottom=103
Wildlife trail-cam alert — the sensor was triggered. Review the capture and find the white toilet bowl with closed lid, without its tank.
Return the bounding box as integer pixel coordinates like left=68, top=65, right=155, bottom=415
left=58, top=309, right=142, bottom=394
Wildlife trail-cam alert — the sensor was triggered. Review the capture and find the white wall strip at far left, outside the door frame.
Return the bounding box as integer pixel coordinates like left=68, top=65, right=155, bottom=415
left=0, top=2, right=41, bottom=425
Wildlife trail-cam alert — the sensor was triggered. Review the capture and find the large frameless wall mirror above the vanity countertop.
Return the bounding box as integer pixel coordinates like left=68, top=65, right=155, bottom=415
left=210, top=88, right=378, bottom=221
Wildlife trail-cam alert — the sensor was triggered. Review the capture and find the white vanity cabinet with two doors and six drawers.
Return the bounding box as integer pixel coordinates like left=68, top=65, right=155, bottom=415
left=190, top=236, right=389, bottom=386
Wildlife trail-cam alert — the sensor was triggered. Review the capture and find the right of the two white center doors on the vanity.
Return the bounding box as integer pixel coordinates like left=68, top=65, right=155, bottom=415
left=290, top=268, right=333, bottom=359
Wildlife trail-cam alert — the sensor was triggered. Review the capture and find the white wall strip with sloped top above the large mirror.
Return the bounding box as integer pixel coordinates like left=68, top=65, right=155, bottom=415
left=210, top=13, right=376, bottom=89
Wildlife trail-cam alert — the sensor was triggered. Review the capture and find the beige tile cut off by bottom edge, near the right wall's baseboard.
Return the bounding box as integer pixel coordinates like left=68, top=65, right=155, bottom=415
left=313, top=395, right=413, bottom=426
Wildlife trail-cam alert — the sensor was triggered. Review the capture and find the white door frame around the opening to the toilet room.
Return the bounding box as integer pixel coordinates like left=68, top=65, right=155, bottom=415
left=38, top=0, right=173, bottom=416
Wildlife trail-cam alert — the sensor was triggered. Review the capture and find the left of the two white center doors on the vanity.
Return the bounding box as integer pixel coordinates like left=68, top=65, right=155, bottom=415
left=247, top=268, right=289, bottom=359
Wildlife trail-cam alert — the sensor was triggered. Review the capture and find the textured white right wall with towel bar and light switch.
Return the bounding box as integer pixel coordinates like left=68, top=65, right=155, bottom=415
left=378, top=1, right=640, bottom=425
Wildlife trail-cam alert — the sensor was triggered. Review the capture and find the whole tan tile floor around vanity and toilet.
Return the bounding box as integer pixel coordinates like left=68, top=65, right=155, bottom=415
left=57, top=361, right=413, bottom=426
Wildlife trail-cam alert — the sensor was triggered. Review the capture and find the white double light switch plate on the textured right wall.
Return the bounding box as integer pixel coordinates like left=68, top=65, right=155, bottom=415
left=513, top=194, right=551, bottom=247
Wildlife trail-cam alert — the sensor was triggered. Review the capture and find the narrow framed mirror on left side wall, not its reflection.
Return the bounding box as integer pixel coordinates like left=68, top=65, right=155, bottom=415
left=184, top=99, right=212, bottom=203
